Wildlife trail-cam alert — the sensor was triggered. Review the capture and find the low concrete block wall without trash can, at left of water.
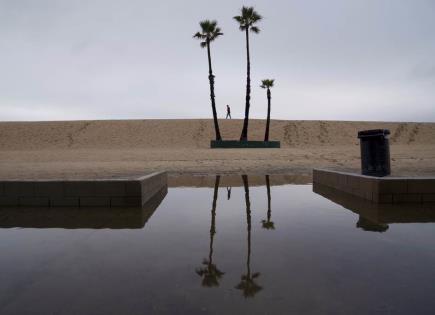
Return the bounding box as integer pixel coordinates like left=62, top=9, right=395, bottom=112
left=0, top=172, right=167, bottom=207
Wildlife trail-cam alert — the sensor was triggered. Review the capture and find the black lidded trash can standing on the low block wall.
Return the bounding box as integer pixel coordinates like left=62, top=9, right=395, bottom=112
left=358, top=129, right=391, bottom=177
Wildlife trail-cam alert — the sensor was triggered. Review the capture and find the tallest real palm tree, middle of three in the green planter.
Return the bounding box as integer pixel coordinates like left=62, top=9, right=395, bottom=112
left=234, top=7, right=262, bottom=141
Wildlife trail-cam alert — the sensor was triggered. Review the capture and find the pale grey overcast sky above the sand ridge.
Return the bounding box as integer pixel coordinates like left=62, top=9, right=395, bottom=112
left=0, top=0, right=435, bottom=122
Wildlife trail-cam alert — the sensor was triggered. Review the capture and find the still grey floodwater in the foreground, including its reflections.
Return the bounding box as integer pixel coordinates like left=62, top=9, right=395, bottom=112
left=0, top=176, right=435, bottom=314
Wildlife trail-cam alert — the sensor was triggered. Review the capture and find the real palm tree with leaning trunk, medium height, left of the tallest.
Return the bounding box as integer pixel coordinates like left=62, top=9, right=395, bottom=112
left=193, top=20, right=223, bottom=141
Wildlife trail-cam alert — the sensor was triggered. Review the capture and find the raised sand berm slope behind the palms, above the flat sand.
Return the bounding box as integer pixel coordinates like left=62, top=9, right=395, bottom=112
left=0, top=119, right=435, bottom=150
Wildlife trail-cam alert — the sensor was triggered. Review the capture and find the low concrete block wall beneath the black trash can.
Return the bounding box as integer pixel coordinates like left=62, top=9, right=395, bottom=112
left=313, top=169, right=435, bottom=204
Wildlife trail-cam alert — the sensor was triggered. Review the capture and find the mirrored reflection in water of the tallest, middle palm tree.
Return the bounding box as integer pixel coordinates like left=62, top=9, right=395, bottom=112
left=236, top=175, right=262, bottom=298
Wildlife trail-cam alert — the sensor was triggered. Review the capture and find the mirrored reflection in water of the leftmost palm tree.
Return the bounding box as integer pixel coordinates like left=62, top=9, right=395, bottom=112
left=196, top=176, right=224, bottom=287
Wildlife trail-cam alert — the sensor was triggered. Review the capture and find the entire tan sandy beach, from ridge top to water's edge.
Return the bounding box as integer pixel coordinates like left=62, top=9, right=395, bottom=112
left=0, top=119, right=435, bottom=179
